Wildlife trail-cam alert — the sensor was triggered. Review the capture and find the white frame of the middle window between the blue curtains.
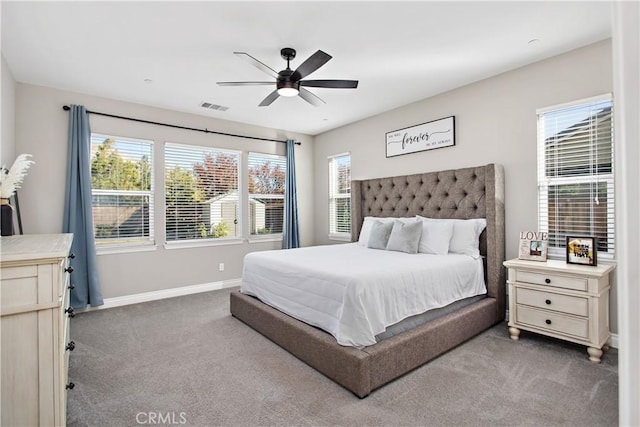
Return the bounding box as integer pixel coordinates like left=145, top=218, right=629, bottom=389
left=162, top=141, right=244, bottom=249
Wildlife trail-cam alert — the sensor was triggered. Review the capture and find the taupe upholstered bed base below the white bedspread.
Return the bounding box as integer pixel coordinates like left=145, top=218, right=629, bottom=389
left=231, top=291, right=496, bottom=397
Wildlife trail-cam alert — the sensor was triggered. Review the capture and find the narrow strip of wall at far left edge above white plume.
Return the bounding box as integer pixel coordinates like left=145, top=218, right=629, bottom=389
left=0, top=55, right=16, bottom=167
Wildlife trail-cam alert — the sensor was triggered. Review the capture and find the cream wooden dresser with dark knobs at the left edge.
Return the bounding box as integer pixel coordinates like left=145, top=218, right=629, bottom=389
left=0, top=234, right=74, bottom=426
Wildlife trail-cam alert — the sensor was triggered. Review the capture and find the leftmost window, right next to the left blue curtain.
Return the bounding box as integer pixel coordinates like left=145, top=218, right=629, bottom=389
left=91, top=134, right=154, bottom=246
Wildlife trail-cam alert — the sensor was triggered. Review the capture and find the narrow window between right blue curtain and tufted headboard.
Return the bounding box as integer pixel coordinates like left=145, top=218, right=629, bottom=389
left=329, top=153, right=351, bottom=240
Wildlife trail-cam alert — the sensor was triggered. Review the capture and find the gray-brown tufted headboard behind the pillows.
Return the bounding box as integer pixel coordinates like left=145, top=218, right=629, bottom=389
left=351, top=164, right=505, bottom=318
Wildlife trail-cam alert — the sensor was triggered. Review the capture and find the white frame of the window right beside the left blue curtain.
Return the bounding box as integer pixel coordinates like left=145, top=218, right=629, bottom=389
left=89, top=132, right=157, bottom=255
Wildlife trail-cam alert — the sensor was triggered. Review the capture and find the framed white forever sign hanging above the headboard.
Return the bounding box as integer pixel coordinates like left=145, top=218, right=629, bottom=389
left=386, top=116, right=456, bottom=157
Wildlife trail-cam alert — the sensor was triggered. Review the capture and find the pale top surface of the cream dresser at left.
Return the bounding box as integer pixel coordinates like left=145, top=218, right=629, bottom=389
left=0, top=233, right=73, bottom=263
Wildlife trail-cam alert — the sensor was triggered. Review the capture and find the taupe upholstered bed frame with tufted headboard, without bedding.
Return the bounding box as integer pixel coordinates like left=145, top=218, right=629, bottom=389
left=230, top=164, right=505, bottom=398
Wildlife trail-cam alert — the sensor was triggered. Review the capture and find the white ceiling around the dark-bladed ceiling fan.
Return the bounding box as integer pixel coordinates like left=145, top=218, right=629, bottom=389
left=1, top=0, right=611, bottom=135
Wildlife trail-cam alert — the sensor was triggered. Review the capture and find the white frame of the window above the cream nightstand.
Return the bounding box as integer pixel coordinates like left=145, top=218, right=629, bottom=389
left=536, top=93, right=616, bottom=262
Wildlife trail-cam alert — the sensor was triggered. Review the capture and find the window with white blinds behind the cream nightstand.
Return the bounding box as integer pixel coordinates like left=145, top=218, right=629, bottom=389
left=538, top=96, right=615, bottom=259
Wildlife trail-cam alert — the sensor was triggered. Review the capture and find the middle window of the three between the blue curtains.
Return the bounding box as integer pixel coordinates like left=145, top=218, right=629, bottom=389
left=164, top=143, right=242, bottom=242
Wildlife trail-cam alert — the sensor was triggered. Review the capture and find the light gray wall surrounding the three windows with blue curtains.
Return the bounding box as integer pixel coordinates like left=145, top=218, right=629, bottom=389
left=16, top=83, right=314, bottom=298
